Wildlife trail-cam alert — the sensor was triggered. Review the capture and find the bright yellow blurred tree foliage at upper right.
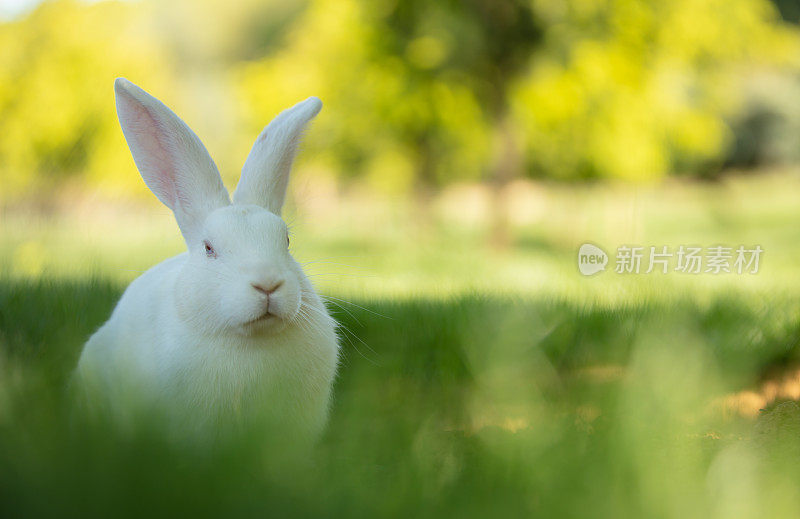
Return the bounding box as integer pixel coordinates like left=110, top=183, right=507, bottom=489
left=514, top=0, right=800, bottom=180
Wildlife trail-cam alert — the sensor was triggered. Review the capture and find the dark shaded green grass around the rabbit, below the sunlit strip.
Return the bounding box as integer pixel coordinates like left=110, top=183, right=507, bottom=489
left=0, top=280, right=800, bottom=517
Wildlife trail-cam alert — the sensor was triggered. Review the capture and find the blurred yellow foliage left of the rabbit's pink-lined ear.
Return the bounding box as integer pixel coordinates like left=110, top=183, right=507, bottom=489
left=0, top=0, right=173, bottom=198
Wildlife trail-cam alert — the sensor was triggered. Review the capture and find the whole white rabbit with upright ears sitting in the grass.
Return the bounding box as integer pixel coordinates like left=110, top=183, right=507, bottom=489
left=70, top=78, right=339, bottom=437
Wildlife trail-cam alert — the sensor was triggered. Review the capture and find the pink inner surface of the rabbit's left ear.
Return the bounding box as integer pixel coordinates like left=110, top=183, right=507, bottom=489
left=118, top=91, right=178, bottom=210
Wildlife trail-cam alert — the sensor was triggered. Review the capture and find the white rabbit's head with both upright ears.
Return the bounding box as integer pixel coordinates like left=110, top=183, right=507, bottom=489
left=115, top=79, right=322, bottom=334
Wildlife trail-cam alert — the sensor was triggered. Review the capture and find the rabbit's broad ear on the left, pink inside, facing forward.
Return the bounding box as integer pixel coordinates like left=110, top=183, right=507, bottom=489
left=114, top=78, right=230, bottom=244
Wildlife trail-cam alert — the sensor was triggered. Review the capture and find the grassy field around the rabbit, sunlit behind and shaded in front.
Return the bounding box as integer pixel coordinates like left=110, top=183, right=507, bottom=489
left=0, top=172, right=800, bottom=518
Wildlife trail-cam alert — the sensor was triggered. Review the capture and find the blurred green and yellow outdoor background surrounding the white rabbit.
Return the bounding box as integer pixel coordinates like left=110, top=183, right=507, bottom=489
left=0, top=0, right=800, bottom=518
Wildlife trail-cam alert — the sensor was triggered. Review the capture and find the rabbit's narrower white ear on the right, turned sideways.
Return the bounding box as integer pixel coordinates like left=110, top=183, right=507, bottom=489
left=233, top=97, right=322, bottom=215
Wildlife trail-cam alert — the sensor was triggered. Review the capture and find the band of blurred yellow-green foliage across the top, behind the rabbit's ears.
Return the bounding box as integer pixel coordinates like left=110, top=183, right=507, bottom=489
left=0, top=0, right=800, bottom=199
